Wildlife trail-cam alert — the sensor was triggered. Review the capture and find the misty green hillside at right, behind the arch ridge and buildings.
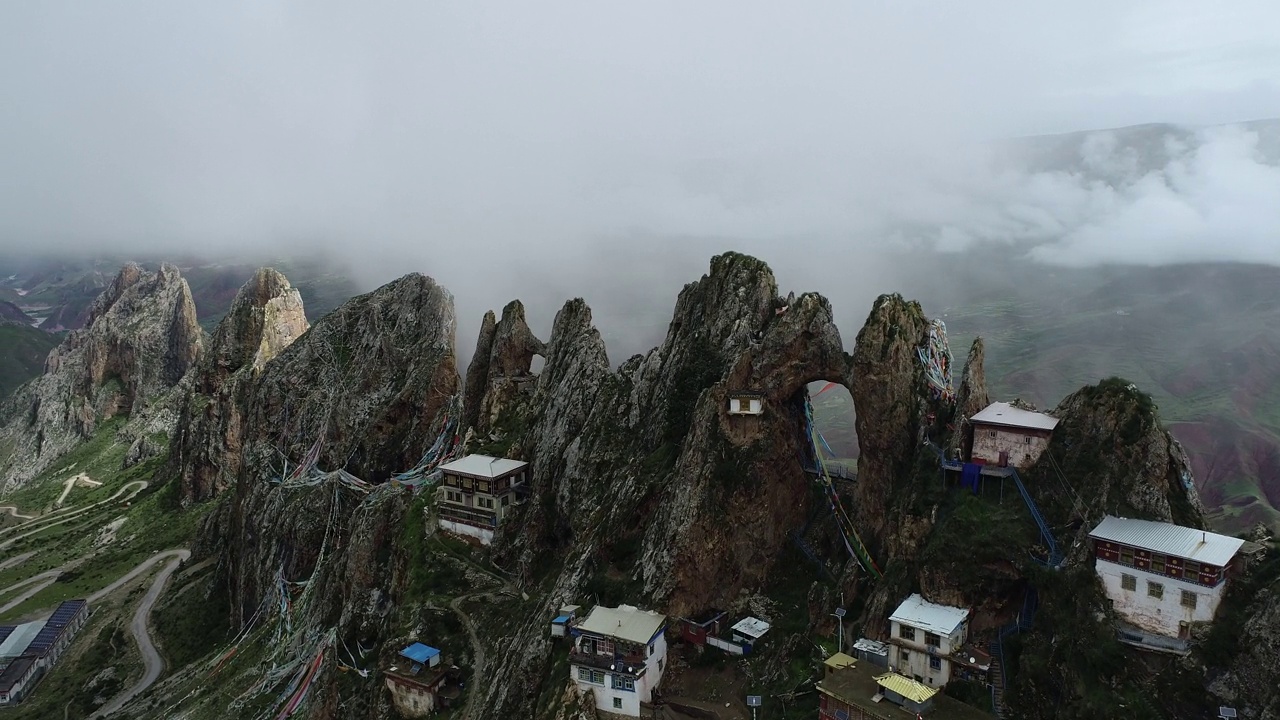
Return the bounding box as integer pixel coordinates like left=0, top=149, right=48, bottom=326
left=933, top=257, right=1280, bottom=532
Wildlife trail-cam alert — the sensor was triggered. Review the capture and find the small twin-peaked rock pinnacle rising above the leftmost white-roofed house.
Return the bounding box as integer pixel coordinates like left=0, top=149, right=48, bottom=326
left=462, top=300, right=547, bottom=437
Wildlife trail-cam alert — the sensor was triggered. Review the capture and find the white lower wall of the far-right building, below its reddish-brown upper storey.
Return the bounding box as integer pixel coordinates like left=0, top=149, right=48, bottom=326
left=1094, top=560, right=1226, bottom=630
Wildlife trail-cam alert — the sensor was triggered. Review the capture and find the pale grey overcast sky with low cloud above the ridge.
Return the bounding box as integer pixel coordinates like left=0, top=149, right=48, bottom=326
left=0, top=0, right=1280, bottom=353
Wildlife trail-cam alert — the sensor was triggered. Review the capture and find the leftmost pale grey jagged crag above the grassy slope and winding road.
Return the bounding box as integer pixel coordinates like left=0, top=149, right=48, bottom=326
left=0, top=264, right=204, bottom=489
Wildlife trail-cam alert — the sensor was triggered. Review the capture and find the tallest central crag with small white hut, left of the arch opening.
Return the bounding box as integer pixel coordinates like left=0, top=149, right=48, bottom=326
left=465, top=254, right=865, bottom=716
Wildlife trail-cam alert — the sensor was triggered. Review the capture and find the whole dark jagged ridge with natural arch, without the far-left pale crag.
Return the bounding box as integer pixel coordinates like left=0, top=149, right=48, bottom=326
left=157, top=254, right=1265, bottom=719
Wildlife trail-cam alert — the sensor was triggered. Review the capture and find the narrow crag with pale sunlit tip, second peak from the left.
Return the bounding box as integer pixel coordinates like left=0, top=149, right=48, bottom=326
left=166, top=268, right=308, bottom=505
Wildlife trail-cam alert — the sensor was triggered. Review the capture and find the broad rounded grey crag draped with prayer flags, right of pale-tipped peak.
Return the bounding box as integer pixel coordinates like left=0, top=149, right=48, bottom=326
left=194, top=274, right=460, bottom=626
